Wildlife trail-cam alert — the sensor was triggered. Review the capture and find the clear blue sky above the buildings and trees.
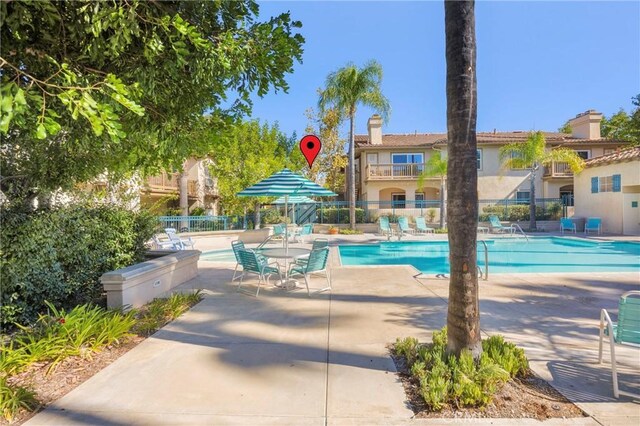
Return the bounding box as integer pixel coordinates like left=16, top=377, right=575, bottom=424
left=253, top=1, right=640, bottom=136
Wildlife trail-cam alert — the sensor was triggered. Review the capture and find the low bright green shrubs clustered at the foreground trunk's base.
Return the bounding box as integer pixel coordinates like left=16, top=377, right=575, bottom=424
left=394, top=327, right=529, bottom=411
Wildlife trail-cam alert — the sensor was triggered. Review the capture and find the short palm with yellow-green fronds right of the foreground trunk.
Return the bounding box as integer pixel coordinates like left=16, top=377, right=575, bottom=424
left=500, top=131, right=584, bottom=231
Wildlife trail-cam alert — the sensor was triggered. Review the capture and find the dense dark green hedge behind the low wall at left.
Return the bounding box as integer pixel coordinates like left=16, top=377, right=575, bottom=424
left=0, top=206, right=157, bottom=328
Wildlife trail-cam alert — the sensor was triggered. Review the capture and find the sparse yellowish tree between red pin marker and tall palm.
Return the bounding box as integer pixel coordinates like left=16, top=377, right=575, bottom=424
left=305, top=109, right=347, bottom=193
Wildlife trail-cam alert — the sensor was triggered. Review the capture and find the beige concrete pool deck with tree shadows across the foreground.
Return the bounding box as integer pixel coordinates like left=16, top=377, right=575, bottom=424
left=27, top=235, right=640, bottom=425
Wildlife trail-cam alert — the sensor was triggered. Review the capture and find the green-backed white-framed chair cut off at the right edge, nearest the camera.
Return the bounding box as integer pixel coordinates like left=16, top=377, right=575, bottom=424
left=598, top=291, right=640, bottom=398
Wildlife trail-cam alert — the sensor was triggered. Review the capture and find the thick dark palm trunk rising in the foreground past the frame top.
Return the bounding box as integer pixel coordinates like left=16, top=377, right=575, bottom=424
left=444, top=0, right=482, bottom=357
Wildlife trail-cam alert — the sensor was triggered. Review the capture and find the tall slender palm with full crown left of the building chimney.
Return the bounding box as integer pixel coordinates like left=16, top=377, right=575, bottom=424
left=318, top=61, right=390, bottom=229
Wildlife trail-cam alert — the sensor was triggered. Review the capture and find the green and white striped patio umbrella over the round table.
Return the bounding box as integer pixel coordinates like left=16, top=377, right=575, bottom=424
left=237, top=168, right=338, bottom=248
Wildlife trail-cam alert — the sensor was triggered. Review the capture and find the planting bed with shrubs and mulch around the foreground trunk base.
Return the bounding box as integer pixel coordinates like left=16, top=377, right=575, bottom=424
left=391, top=329, right=586, bottom=420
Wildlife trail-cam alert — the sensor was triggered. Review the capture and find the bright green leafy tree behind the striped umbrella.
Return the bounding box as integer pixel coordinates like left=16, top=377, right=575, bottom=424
left=209, top=120, right=304, bottom=226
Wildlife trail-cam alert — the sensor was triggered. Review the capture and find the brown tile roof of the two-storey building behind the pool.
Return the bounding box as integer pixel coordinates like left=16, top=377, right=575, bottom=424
left=355, top=131, right=627, bottom=149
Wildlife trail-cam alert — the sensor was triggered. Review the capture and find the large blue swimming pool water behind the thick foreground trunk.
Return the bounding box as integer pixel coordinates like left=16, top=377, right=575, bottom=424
left=339, top=237, right=640, bottom=274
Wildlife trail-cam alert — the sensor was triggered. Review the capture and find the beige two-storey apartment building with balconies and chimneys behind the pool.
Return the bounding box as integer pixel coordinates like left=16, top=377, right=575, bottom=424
left=355, top=110, right=625, bottom=215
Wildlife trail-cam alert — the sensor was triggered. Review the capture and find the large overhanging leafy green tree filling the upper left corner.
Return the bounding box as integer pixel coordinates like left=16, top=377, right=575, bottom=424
left=0, top=0, right=304, bottom=201
